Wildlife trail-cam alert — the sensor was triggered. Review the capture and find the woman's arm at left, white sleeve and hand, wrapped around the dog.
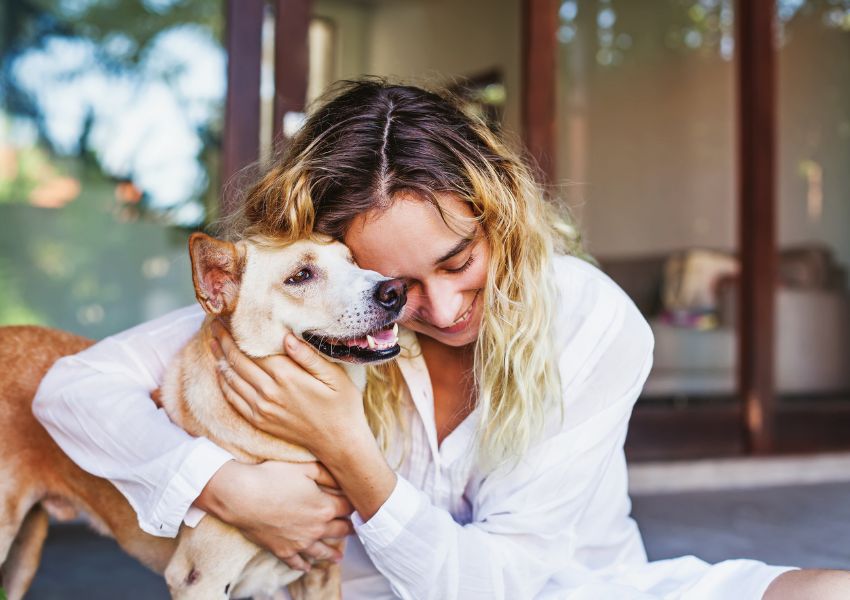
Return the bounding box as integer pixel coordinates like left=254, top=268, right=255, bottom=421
left=33, top=306, right=351, bottom=568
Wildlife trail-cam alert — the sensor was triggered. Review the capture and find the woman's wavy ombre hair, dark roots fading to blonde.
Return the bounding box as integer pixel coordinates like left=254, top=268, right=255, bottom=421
left=219, top=77, right=581, bottom=468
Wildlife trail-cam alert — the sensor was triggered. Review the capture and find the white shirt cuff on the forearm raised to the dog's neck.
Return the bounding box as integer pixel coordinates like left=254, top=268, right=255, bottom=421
left=351, top=475, right=423, bottom=550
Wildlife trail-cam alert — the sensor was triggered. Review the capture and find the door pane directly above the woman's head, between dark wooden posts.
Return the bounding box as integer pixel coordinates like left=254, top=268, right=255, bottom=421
left=310, top=0, right=520, bottom=126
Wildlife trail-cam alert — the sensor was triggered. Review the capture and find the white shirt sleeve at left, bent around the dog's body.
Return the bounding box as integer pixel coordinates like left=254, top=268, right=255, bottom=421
left=33, top=306, right=233, bottom=537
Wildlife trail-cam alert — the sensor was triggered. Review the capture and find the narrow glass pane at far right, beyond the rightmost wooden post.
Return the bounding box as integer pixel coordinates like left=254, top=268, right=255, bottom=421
left=775, top=0, right=850, bottom=404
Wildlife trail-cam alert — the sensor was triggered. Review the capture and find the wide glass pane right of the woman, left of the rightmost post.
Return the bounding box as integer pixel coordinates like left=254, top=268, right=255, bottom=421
left=557, top=0, right=738, bottom=410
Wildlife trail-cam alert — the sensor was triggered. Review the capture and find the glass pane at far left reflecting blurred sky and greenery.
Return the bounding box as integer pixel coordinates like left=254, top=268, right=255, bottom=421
left=0, top=0, right=225, bottom=337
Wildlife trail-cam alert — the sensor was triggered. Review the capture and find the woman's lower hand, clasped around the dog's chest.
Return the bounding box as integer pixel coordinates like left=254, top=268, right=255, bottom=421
left=195, top=461, right=353, bottom=571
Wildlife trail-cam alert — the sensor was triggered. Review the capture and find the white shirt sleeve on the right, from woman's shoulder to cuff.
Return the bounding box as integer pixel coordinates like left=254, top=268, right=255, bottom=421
left=354, top=279, right=654, bottom=600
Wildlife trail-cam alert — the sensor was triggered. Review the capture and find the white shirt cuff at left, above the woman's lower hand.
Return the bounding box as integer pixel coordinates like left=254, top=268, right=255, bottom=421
left=139, top=438, right=235, bottom=537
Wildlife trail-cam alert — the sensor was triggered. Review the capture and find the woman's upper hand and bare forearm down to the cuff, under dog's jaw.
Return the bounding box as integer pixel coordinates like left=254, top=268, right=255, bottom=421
left=212, top=323, right=396, bottom=521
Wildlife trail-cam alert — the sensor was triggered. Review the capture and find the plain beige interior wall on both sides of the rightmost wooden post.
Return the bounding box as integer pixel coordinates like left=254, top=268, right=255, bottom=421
left=558, top=0, right=850, bottom=268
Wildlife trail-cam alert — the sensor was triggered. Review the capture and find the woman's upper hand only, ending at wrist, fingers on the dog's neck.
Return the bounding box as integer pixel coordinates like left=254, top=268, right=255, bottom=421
left=207, top=322, right=374, bottom=462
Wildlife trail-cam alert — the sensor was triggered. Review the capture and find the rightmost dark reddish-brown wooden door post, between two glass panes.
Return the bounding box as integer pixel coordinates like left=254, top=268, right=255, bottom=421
left=735, top=0, right=778, bottom=454
